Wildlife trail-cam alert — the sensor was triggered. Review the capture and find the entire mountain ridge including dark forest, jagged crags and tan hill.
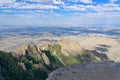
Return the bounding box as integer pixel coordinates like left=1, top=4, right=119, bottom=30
left=0, top=39, right=108, bottom=80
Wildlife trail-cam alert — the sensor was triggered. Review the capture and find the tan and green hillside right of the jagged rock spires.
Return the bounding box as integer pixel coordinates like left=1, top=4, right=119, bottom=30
left=41, top=39, right=108, bottom=66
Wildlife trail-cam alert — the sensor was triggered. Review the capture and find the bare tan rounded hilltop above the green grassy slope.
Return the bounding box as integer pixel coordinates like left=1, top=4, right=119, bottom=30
left=57, top=39, right=85, bottom=56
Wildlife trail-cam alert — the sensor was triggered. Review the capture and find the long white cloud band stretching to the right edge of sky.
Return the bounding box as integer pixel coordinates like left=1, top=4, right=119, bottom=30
left=63, top=3, right=120, bottom=12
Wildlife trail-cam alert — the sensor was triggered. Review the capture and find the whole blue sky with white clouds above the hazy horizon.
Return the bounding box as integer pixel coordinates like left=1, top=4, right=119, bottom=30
left=0, top=0, right=120, bottom=27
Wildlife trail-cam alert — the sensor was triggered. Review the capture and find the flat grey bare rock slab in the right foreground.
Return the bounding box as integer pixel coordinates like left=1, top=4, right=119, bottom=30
left=47, top=62, right=120, bottom=80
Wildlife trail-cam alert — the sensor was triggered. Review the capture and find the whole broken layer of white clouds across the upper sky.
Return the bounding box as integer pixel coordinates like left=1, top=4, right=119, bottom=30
left=0, top=0, right=120, bottom=17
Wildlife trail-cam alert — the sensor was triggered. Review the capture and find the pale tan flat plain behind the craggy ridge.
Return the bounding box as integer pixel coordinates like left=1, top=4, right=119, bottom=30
left=0, top=34, right=120, bottom=62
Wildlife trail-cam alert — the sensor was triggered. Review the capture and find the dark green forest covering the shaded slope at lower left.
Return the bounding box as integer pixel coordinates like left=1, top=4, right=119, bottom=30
left=0, top=51, right=48, bottom=80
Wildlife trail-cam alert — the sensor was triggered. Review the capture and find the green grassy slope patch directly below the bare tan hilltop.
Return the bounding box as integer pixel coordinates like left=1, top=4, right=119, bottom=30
left=48, top=44, right=83, bottom=66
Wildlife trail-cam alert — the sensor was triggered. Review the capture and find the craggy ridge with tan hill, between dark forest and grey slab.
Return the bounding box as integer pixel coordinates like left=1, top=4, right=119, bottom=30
left=14, top=39, right=108, bottom=69
